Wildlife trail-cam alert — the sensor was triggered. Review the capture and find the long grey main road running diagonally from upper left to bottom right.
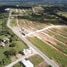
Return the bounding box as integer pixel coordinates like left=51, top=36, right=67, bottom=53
left=7, top=11, right=59, bottom=67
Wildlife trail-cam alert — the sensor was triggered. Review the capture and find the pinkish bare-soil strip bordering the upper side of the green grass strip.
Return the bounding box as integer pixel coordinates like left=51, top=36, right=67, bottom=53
left=37, top=32, right=67, bottom=54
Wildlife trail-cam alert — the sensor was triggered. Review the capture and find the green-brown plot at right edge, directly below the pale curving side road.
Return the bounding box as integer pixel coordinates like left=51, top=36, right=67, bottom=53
left=46, top=28, right=67, bottom=44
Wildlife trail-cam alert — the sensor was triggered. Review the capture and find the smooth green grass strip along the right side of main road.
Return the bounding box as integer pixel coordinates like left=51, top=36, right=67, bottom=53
left=28, top=37, right=67, bottom=67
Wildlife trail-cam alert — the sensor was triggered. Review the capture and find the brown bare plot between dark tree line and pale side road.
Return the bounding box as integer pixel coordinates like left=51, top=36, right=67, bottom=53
left=19, top=19, right=49, bottom=31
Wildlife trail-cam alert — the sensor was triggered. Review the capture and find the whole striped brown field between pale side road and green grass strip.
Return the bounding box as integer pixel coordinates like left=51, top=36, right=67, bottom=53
left=28, top=27, right=67, bottom=55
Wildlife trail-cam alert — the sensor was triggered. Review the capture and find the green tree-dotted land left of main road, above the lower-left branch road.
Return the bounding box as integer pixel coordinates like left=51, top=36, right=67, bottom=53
left=0, top=13, right=27, bottom=67
